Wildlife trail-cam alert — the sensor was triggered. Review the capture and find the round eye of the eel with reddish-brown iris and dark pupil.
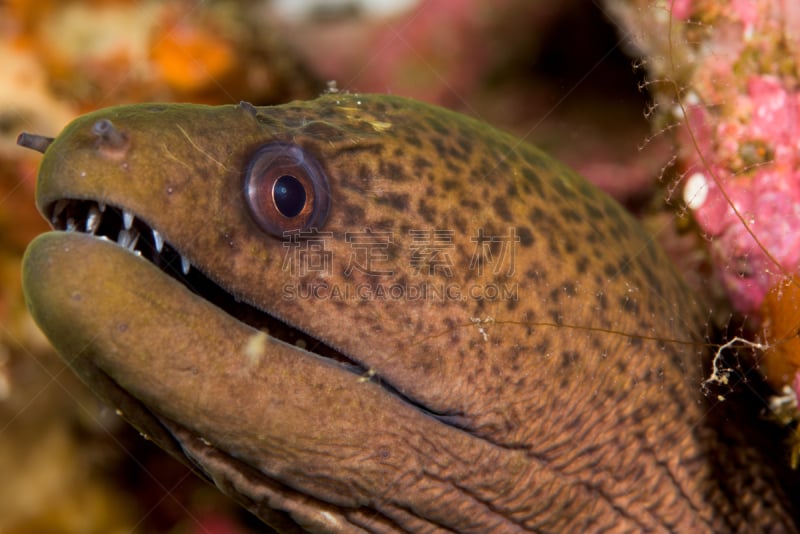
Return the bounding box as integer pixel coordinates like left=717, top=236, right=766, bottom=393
left=244, top=143, right=331, bottom=237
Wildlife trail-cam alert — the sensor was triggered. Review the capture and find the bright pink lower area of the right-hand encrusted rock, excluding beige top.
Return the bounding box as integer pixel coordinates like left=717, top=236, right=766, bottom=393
left=688, top=75, right=800, bottom=313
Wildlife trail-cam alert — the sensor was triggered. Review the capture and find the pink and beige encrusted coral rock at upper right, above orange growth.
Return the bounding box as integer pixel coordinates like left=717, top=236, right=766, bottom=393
left=607, top=0, right=800, bottom=319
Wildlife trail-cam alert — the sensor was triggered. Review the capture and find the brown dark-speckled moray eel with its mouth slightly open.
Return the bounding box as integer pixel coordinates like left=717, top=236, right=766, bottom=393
left=19, top=94, right=795, bottom=533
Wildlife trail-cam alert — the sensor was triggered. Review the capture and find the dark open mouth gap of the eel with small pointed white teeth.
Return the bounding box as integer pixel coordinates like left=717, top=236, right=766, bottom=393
left=46, top=199, right=356, bottom=368
